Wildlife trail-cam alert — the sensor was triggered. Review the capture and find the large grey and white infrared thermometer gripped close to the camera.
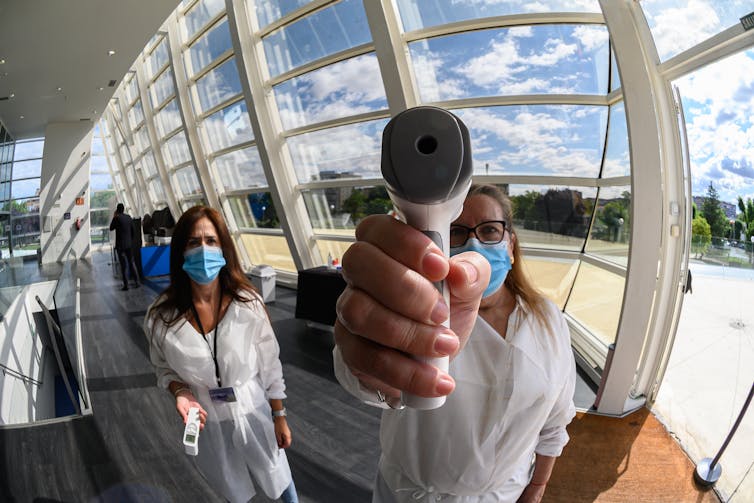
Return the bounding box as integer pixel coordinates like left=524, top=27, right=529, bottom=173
left=382, top=106, right=473, bottom=409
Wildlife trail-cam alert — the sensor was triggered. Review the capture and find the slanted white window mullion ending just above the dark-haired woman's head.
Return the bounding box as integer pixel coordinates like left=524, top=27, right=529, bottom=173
left=167, top=13, right=222, bottom=213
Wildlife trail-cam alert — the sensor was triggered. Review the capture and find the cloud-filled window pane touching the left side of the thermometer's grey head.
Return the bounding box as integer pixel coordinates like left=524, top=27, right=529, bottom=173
left=288, top=119, right=387, bottom=183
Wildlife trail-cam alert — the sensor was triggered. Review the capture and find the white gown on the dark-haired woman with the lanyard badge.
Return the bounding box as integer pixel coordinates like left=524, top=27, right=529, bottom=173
left=144, top=292, right=291, bottom=502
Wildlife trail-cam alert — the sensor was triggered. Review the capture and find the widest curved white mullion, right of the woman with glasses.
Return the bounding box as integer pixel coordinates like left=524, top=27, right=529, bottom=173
left=598, top=0, right=685, bottom=415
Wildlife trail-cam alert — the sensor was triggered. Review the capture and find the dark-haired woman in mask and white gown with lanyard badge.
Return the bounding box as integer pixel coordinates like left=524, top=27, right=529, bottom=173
left=144, top=206, right=298, bottom=502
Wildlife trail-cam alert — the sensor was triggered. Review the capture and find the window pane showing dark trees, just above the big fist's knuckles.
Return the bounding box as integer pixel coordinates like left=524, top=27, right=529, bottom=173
left=301, top=186, right=393, bottom=232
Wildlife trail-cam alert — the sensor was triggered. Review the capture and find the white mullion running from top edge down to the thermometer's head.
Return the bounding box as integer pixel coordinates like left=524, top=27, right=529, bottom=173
left=364, top=0, right=419, bottom=116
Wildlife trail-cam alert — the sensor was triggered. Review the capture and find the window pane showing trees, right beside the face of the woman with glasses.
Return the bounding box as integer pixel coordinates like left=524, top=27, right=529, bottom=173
left=508, top=186, right=597, bottom=251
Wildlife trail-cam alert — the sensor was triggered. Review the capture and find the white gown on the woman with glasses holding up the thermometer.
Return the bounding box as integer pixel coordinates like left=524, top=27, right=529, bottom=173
left=333, top=301, right=576, bottom=503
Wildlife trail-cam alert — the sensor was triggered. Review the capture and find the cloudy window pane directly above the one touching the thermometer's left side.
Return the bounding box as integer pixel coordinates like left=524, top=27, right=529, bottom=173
left=274, top=53, right=387, bottom=129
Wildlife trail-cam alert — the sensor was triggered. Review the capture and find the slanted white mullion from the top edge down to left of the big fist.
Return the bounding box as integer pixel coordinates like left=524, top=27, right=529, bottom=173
left=225, top=0, right=323, bottom=271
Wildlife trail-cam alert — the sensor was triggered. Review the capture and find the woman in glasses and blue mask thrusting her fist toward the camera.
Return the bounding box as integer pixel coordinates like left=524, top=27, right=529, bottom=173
left=334, top=185, right=575, bottom=503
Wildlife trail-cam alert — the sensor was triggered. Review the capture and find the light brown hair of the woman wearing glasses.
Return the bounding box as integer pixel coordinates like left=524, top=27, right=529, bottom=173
left=466, top=184, right=547, bottom=321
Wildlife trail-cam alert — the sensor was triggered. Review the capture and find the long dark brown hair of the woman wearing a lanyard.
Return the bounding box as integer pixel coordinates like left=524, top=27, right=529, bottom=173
left=148, top=206, right=258, bottom=326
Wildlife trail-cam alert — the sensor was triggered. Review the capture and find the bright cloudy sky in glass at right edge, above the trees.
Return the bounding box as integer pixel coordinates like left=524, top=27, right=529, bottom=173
left=676, top=49, right=754, bottom=203
